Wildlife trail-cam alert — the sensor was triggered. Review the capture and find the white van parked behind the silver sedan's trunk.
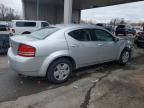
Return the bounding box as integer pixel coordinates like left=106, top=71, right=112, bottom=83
left=10, top=20, right=49, bottom=35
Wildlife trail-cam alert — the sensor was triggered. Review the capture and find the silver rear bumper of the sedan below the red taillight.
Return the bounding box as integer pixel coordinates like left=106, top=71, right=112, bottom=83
left=8, top=48, right=44, bottom=76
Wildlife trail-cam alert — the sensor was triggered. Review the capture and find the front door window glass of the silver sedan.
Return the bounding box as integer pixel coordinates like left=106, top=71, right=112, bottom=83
left=94, top=29, right=113, bottom=41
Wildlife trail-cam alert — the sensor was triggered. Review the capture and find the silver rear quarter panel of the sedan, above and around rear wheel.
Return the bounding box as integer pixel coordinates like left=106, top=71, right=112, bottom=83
left=27, top=32, right=70, bottom=76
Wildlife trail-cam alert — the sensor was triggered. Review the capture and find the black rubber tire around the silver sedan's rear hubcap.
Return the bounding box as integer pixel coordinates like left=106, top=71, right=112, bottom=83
left=47, top=58, right=73, bottom=84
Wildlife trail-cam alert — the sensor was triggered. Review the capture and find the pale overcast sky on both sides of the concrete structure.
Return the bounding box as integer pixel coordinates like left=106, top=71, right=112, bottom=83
left=0, top=0, right=144, bottom=23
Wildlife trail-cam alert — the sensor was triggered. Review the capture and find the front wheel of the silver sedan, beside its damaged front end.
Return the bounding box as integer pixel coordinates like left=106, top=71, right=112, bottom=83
left=118, top=49, right=131, bottom=65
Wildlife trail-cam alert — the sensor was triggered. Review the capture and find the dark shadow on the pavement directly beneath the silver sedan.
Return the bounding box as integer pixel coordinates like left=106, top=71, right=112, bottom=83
left=17, top=62, right=135, bottom=89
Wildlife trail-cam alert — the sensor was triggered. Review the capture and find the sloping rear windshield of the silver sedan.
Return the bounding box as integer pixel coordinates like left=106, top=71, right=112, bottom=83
left=30, top=27, right=59, bottom=39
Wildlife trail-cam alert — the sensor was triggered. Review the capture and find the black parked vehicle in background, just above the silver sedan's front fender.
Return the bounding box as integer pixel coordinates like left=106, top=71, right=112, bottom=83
left=115, top=24, right=136, bottom=36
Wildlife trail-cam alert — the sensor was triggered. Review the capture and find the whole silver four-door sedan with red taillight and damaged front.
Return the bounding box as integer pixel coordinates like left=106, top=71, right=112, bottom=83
left=8, top=25, right=131, bottom=83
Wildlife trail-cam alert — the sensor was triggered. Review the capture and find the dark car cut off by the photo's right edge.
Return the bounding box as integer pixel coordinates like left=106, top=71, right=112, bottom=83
left=134, top=32, right=144, bottom=47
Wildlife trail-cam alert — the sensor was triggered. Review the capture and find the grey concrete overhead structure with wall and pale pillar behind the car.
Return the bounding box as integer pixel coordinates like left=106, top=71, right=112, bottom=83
left=22, top=0, right=142, bottom=24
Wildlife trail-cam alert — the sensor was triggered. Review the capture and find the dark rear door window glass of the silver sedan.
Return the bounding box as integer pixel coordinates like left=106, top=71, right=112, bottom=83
left=68, top=29, right=90, bottom=41
